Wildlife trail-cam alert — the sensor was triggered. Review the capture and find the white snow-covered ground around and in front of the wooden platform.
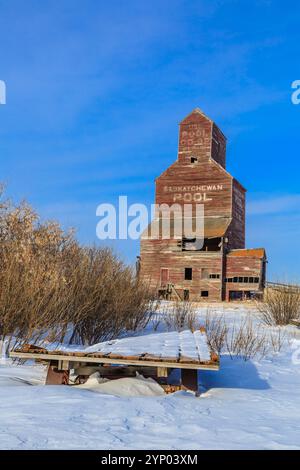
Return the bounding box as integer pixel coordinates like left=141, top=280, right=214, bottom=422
left=0, top=309, right=300, bottom=449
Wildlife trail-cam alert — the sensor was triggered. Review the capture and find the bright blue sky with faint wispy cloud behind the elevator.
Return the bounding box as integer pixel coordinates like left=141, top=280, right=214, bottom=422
left=0, top=0, right=300, bottom=281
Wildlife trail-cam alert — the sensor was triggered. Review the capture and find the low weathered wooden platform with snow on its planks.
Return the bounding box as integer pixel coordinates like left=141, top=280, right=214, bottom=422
left=10, top=330, right=219, bottom=392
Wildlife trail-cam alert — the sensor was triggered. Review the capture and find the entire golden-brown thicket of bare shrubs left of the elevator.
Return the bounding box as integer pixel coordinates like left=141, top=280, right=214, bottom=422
left=0, top=187, right=152, bottom=344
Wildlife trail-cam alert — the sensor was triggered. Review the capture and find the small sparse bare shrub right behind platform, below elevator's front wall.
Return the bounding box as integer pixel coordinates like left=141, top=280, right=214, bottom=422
left=161, top=301, right=199, bottom=331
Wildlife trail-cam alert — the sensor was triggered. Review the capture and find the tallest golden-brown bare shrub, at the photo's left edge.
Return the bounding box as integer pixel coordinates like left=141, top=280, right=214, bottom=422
left=0, top=193, right=75, bottom=350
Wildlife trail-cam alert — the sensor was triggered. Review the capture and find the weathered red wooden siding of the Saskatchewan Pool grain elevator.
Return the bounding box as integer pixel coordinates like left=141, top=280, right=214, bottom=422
left=140, top=109, right=265, bottom=300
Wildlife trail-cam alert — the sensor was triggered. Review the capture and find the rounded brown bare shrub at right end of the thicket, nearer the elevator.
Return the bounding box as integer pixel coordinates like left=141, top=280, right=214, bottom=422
left=70, top=248, right=152, bottom=344
